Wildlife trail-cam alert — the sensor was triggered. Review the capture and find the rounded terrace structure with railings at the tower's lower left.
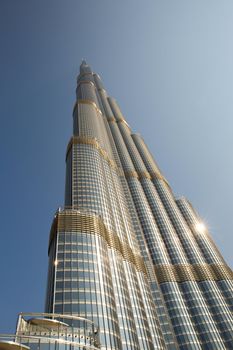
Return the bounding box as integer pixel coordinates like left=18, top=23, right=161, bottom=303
left=0, top=313, right=100, bottom=350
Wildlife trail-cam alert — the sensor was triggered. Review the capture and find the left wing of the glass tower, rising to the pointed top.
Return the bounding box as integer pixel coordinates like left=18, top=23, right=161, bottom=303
left=46, top=62, right=169, bottom=350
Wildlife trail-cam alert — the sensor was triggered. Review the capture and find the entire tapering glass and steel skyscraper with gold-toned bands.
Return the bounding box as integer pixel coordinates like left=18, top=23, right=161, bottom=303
left=0, top=61, right=233, bottom=350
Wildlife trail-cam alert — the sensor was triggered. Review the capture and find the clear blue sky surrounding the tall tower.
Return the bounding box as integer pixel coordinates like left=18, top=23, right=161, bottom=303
left=0, top=0, right=233, bottom=333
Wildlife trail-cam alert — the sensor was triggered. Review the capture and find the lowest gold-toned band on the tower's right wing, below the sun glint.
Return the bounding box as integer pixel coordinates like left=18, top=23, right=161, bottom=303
left=154, top=264, right=233, bottom=283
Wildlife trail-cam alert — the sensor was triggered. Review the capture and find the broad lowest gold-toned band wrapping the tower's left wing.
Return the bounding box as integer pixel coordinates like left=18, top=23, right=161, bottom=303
left=49, top=209, right=147, bottom=274
